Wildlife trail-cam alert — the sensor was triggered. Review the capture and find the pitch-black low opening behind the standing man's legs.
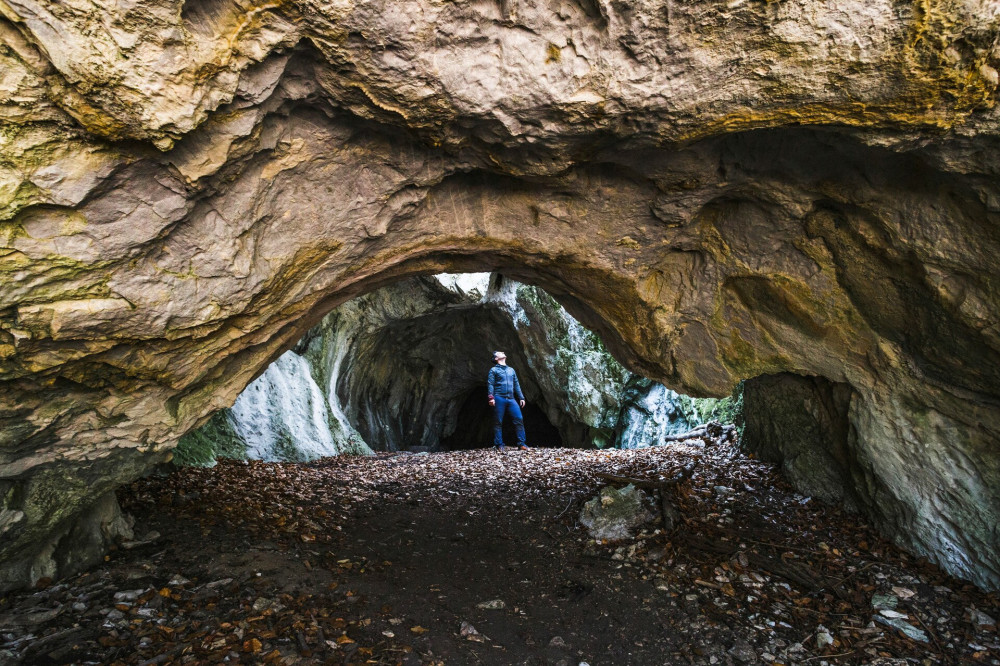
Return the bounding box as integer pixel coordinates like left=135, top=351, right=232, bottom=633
left=441, top=384, right=563, bottom=451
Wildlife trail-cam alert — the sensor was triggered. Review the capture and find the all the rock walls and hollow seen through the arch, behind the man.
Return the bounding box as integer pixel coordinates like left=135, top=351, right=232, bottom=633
left=191, top=273, right=701, bottom=456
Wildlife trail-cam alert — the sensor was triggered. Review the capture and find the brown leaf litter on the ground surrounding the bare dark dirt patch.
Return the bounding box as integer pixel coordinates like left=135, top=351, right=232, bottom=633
left=0, top=441, right=1000, bottom=664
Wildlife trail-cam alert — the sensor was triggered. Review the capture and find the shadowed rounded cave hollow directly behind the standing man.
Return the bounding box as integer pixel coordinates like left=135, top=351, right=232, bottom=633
left=336, top=275, right=576, bottom=451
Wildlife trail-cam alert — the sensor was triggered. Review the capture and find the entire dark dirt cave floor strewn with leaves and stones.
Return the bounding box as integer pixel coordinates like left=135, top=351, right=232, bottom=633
left=0, top=441, right=1000, bottom=666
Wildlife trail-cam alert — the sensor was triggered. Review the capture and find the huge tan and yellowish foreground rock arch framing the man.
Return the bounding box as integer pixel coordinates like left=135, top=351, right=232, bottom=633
left=0, top=0, right=1000, bottom=588
